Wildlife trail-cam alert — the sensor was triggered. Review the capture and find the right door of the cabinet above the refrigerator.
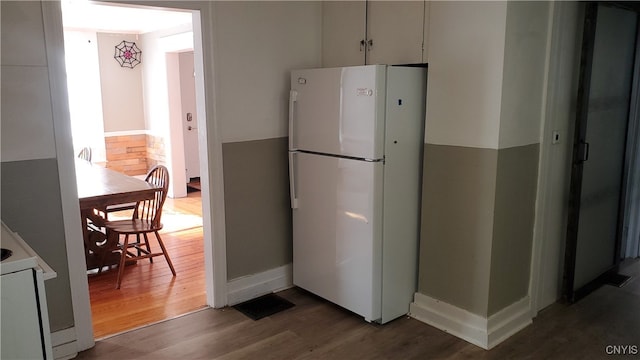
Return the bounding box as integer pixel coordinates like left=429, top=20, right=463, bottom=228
left=366, top=1, right=426, bottom=64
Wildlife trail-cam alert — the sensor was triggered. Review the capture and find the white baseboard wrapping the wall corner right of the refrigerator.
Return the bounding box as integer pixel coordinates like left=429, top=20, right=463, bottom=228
left=409, top=293, right=531, bottom=350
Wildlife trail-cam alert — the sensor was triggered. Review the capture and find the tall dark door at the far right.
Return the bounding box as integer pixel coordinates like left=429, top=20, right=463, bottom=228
left=564, top=3, right=638, bottom=302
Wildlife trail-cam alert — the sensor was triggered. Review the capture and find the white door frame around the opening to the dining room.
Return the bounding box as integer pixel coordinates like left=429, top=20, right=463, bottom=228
left=42, top=0, right=227, bottom=351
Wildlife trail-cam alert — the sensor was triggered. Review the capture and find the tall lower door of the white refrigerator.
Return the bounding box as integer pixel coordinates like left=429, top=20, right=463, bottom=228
left=293, top=153, right=383, bottom=321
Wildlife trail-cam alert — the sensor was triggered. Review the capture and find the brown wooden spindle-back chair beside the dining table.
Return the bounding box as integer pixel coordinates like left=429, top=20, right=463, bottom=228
left=105, top=165, right=176, bottom=289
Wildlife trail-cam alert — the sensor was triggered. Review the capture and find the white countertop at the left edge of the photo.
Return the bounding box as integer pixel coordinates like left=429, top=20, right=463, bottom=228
left=0, top=222, right=57, bottom=280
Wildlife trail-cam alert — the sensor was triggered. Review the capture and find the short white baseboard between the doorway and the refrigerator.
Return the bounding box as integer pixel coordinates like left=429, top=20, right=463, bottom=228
left=227, top=264, right=293, bottom=305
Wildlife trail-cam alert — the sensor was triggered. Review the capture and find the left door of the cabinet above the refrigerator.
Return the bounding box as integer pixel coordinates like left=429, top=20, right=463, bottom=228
left=322, top=1, right=367, bottom=67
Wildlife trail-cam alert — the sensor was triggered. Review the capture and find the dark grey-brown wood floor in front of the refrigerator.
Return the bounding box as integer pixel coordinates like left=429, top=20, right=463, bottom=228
left=78, top=261, right=640, bottom=360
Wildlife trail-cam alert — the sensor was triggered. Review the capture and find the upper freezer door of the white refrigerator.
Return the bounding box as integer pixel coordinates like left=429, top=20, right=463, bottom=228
left=289, top=65, right=386, bottom=159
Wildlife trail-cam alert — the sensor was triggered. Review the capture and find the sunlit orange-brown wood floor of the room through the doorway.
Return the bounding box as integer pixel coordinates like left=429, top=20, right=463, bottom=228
left=89, top=192, right=206, bottom=339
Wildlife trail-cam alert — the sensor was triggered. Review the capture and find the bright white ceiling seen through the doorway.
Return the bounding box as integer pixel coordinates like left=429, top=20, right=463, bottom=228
left=62, top=0, right=191, bottom=34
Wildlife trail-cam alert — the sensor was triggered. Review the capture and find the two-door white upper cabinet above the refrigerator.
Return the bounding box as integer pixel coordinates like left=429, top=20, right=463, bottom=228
left=322, top=1, right=429, bottom=67
